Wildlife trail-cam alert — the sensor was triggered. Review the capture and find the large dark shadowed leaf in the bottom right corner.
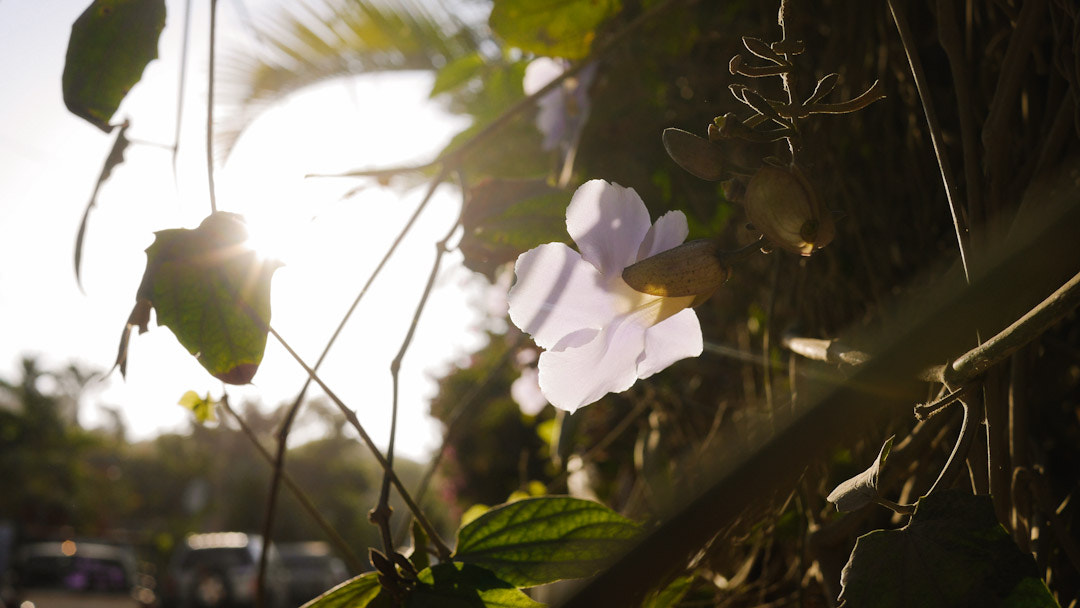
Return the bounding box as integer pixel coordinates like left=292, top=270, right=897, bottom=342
left=840, top=489, right=1057, bottom=608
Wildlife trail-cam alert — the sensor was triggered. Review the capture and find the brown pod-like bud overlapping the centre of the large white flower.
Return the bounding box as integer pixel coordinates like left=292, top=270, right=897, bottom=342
left=622, top=239, right=731, bottom=297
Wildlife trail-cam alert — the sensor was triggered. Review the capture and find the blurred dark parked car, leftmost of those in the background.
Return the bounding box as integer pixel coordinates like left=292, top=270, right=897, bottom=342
left=12, top=540, right=154, bottom=608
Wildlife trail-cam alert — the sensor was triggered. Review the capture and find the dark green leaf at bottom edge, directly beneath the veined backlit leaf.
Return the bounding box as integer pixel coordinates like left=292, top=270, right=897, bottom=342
left=405, top=563, right=543, bottom=608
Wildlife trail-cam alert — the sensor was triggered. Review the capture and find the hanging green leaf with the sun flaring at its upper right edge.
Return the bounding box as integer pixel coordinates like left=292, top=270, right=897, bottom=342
left=117, top=212, right=281, bottom=384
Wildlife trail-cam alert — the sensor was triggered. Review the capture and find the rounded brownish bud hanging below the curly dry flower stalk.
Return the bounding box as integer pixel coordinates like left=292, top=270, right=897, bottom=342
left=743, top=165, right=836, bottom=256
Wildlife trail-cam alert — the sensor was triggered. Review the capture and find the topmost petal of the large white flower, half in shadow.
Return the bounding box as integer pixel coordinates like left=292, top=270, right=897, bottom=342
left=566, top=179, right=651, bottom=279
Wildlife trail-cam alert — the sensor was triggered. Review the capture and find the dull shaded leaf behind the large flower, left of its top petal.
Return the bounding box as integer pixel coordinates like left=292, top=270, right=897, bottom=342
left=460, top=179, right=569, bottom=279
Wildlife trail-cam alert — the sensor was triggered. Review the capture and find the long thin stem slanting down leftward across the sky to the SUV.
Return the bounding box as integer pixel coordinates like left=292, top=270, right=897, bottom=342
left=258, top=166, right=446, bottom=581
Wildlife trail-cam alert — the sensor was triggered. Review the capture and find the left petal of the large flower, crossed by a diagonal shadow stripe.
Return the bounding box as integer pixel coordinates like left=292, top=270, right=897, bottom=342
left=508, top=243, right=616, bottom=349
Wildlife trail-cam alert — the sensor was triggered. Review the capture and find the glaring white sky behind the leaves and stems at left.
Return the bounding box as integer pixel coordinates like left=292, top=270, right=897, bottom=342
left=0, top=0, right=487, bottom=458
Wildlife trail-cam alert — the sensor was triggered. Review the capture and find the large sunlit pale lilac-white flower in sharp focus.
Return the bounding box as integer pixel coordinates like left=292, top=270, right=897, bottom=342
left=509, top=179, right=702, bottom=411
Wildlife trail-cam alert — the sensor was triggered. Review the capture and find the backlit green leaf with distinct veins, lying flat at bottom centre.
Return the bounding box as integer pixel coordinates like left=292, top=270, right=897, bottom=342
left=455, top=496, right=640, bottom=586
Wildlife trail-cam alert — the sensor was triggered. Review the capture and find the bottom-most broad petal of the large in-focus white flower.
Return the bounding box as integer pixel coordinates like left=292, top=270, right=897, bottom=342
left=539, top=316, right=645, bottom=413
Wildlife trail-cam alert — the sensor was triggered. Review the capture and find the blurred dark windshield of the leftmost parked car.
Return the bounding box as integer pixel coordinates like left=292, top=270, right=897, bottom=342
left=18, top=555, right=131, bottom=592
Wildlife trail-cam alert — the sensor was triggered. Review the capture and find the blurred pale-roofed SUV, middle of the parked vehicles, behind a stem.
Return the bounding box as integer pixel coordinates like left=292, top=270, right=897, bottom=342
left=167, top=532, right=288, bottom=608
